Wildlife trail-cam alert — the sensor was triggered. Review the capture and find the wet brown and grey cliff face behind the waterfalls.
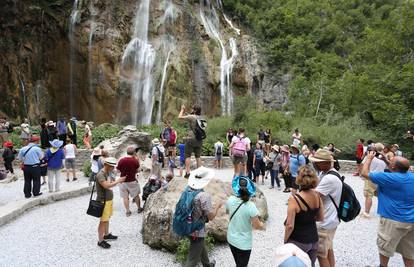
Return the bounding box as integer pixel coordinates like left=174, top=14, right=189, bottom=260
left=0, top=0, right=287, bottom=123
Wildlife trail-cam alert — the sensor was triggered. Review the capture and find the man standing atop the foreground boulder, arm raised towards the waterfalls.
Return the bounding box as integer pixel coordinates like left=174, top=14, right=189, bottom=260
left=178, top=105, right=203, bottom=178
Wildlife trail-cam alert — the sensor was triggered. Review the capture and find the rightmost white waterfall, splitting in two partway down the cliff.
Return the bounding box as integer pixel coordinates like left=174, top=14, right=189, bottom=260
left=200, top=0, right=238, bottom=115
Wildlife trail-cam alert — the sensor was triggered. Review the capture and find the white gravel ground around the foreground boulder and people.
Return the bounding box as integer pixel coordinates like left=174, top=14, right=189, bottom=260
left=0, top=170, right=403, bottom=267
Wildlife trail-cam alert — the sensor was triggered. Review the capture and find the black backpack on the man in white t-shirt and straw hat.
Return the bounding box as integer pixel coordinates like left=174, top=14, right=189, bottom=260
left=327, top=171, right=361, bottom=222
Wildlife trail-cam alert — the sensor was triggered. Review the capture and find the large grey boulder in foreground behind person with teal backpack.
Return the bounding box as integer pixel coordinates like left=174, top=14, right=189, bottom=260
left=142, top=178, right=268, bottom=251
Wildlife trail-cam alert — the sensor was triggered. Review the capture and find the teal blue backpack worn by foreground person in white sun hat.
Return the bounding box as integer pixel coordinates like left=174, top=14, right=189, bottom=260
left=173, top=186, right=205, bottom=236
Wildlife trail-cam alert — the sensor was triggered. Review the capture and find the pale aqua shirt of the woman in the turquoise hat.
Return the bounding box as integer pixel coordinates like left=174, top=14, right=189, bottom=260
left=226, top=196, right=259, bottom=250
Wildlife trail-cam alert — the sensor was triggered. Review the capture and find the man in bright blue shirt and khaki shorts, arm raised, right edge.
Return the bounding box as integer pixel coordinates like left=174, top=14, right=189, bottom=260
left=361, top=151, right=414, bottom=267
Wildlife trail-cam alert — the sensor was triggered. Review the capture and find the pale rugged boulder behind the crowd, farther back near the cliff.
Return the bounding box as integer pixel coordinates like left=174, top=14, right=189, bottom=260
left=98, top=125, right=151, bottom=159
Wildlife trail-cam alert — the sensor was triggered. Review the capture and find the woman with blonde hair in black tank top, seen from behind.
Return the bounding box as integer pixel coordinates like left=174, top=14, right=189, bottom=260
left=284, top=165, right=324, bottom=267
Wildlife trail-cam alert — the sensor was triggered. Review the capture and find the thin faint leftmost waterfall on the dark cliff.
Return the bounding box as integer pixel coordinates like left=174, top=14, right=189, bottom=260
left=69, top=0, right=79, bottom=116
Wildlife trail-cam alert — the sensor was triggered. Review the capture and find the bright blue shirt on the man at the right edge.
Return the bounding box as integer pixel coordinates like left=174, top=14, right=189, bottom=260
left=369, top=172, right=414, bottom=223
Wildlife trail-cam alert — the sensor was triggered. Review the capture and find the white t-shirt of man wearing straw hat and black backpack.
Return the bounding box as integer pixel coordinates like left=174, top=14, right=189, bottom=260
left=316, top=172, right=342, bottom=230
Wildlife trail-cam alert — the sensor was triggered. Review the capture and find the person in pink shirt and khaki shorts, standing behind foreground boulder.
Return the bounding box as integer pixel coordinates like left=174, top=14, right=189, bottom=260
left=229, top=128, right=250, bottom=178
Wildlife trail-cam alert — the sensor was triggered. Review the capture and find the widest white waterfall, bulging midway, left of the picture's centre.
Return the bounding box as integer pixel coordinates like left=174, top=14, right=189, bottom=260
left=121, top=0, right=155, bottom=125
